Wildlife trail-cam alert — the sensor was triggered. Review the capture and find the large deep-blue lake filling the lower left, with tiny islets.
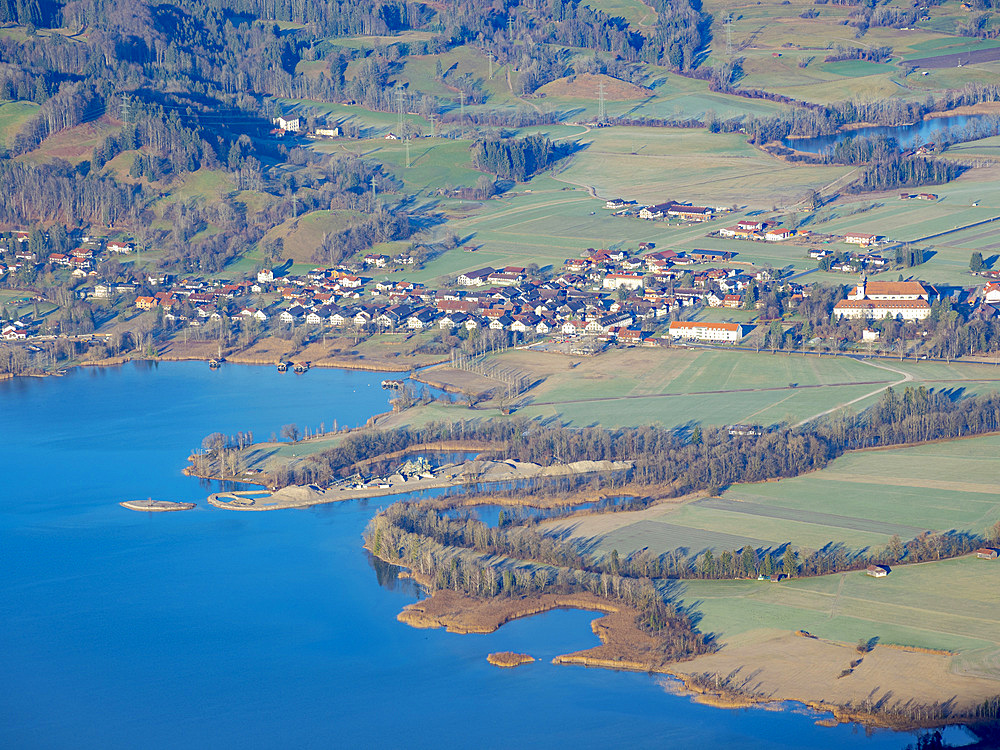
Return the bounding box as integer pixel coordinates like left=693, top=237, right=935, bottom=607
left=0, top=362, right=968, bottom=750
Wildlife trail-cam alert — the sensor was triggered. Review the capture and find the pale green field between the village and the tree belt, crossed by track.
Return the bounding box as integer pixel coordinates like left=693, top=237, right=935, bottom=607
left=392, top=346, right=1000, bottom=428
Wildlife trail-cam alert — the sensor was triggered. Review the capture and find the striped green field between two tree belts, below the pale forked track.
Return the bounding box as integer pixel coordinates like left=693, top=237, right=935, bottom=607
left=553, top=428, right=1000, bottom=555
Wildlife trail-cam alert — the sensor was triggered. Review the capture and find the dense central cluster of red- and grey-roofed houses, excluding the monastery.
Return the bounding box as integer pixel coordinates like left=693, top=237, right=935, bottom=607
left=72, top=244, right=801, bottom=344
